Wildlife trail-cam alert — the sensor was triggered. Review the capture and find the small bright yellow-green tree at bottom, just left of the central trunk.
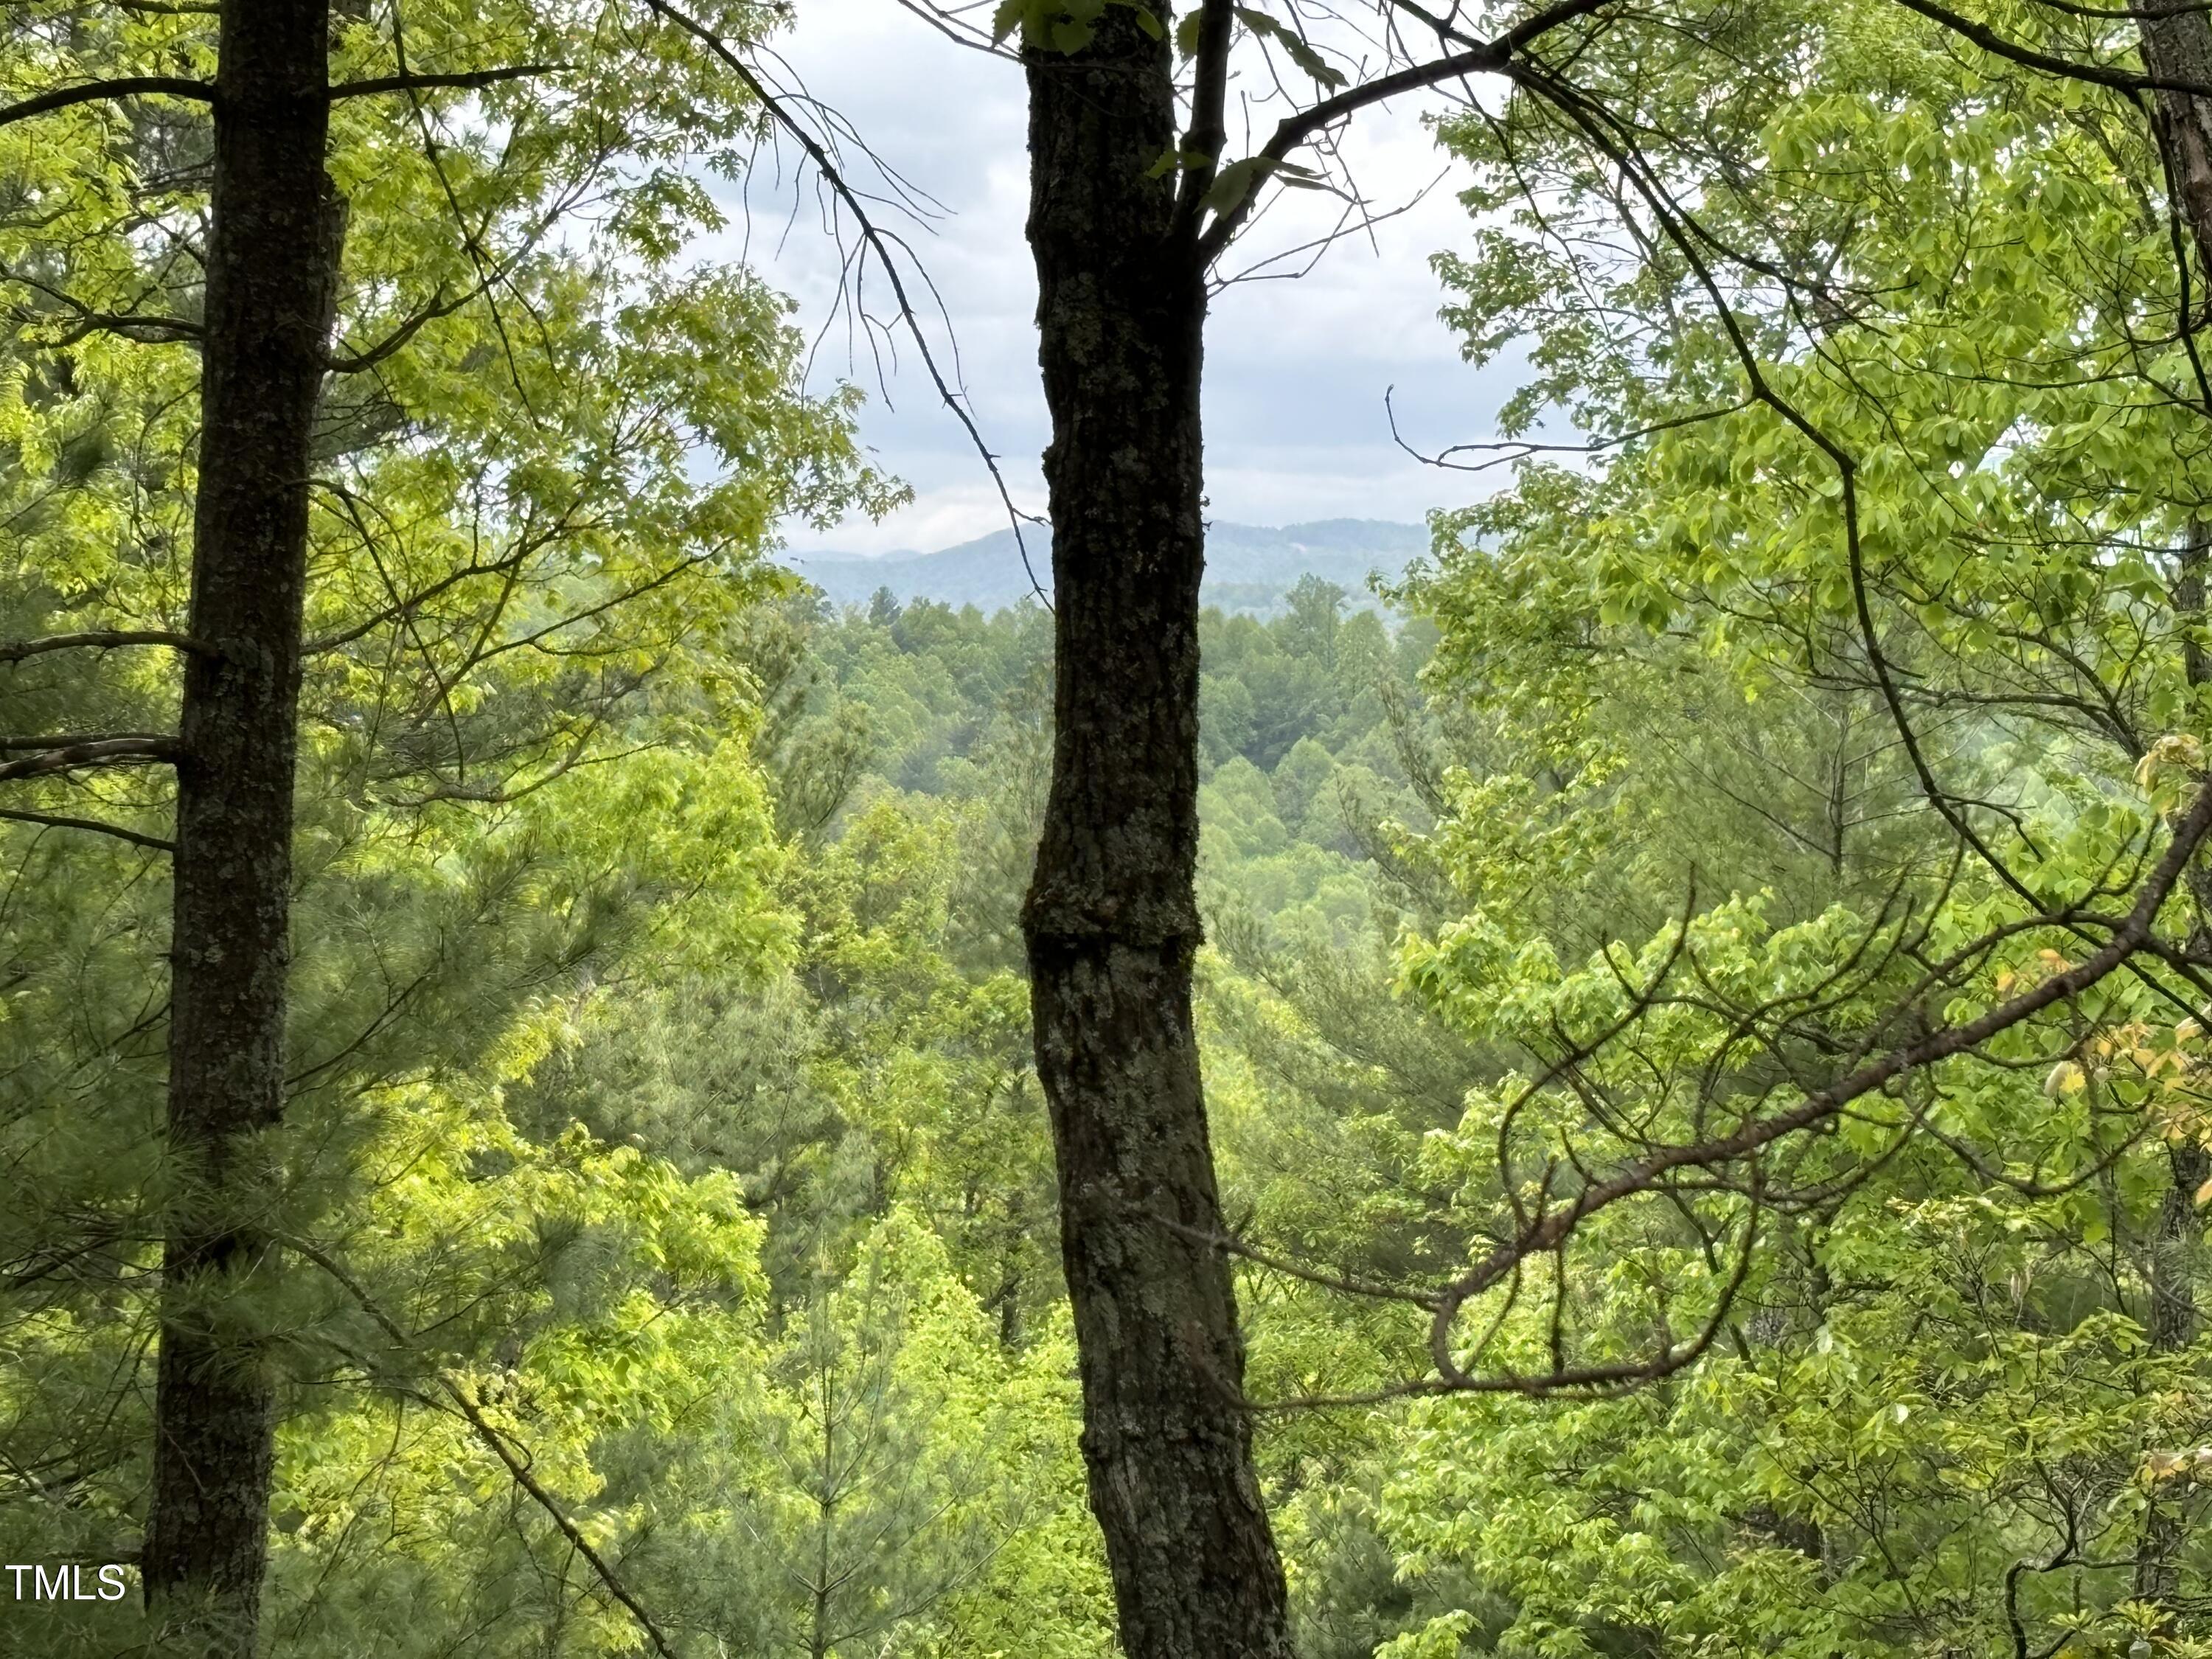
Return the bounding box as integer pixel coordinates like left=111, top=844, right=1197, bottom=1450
left=670, top=1208, right=1095, bottom=1659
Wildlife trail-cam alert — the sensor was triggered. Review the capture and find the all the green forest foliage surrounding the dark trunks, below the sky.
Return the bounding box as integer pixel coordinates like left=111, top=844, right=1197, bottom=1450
left=0, top=0, right=2212, bottom=1659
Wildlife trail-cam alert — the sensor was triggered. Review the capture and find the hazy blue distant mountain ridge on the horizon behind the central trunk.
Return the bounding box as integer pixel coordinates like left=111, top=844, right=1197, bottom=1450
left=790, top=518, right=1429, bottom=615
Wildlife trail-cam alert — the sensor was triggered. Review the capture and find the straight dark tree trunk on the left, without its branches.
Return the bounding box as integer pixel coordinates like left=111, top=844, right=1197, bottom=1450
left=144, top=0, right=343, bottom=1659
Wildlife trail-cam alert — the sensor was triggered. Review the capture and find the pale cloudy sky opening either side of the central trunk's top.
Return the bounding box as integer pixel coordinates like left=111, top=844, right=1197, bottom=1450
left=701, top=0, right=1511, bottom=553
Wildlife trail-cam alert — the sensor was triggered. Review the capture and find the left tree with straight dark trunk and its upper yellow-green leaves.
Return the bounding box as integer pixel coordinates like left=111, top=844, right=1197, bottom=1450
left=0, top=0, right=880, bottom=1652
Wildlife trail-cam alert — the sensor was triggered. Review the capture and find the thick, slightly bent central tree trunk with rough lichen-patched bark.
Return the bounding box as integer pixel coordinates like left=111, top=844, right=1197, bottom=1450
left=1022, top=7, right=1290, bottom=1659
